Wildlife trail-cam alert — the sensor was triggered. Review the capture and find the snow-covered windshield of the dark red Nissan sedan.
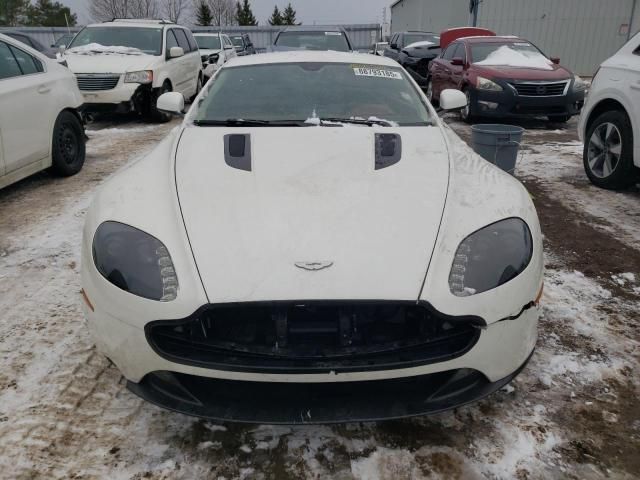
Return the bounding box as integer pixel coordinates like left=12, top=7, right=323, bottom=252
left=471, top=42, right=553, bottom=70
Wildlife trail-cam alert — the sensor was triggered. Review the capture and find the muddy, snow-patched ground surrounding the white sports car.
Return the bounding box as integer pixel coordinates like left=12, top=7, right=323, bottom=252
left=0, top=116, right=640, bottom=480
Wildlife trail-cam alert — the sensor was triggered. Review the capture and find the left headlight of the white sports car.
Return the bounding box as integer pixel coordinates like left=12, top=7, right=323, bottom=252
left=93, top=222, right=178, bottom=302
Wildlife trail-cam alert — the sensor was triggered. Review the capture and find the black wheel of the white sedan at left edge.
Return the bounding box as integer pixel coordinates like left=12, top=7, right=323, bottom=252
left=51, top=111, right=85, bottom=177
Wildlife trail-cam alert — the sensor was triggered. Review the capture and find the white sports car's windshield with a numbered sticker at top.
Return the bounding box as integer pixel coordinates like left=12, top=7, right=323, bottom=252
left=194, top=63, right=431, bottom=125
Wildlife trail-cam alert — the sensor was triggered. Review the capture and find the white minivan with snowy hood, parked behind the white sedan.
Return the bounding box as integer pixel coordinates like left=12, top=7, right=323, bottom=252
left=62, top=20, right=203, bottom=121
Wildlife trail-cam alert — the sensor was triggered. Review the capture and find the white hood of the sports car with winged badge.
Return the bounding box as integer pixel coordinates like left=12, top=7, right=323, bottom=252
left=176, top=127, right=449, bottom=303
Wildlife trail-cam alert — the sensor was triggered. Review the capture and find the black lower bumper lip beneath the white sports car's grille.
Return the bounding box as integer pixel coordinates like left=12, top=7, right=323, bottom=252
left=127, top=352, right=533, bottom=425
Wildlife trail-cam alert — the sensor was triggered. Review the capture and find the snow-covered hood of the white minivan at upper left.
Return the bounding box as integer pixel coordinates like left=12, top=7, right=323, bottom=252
left=62, top=52, right=160, bottom=73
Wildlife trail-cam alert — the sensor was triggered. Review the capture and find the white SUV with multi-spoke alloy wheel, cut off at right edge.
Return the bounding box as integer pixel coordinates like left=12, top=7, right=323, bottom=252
left=578, top=33, right=640, bottom=189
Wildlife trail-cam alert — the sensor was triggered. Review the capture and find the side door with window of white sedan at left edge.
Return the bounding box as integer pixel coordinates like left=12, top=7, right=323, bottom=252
left=0, top=41, right=52, bottom=174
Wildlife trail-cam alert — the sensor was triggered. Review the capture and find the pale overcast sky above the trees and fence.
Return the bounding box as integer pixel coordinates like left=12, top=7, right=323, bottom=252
left=61, top=0, right=392, bottom=25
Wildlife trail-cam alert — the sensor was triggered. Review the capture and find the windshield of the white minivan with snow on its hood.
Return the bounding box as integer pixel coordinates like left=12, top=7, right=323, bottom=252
left=69, top=27, right=162, bottom=55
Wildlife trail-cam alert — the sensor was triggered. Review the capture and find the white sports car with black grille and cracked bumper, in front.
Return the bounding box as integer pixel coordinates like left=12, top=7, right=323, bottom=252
left=77, top=52, right=543, bottom=423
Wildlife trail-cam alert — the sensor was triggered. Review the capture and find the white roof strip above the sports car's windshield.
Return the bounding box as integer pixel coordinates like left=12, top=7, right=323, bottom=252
left=225, top=50, right=399, bottom=68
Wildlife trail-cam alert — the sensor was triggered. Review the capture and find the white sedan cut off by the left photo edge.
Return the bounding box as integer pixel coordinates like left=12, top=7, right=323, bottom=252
left=0, top=34, right=85, bottom=188
